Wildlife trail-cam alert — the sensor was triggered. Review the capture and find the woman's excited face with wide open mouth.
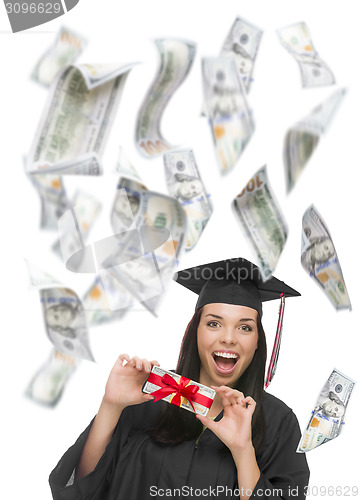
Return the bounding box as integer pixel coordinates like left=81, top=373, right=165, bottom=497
left=197, top=304, right=258, bottom=387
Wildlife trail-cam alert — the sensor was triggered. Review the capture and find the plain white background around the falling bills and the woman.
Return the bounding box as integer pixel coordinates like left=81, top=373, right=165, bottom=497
left=0, top=0, right=360, bottom=500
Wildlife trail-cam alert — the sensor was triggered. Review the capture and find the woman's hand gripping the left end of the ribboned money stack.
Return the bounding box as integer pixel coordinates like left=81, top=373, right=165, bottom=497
left=104, top=354, right=160, bottom=410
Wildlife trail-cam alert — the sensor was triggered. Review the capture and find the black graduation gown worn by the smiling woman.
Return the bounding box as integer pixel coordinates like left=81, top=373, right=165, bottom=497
left=49, top=393, right=309, bottom=500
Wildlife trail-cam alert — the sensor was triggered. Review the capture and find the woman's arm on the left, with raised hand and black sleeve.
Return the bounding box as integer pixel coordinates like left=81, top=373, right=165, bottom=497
left=49, top=354, right=158, bottom=500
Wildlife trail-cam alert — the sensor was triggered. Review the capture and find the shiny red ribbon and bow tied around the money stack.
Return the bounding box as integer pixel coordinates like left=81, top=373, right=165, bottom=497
left=148, top=373, right=213, bottom=413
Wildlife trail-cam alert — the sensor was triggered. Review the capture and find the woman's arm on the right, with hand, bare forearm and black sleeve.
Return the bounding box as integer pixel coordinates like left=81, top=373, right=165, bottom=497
left=197, top=386, right=309, bottom=500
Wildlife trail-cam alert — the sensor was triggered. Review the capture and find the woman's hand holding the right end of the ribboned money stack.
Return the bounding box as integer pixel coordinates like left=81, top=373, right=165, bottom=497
left=196, top=385, right=256, bottom=453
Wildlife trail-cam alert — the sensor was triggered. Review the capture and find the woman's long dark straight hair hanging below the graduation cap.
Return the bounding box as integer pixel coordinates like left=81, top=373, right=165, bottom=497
left=150, top=308, right=266, bottom=454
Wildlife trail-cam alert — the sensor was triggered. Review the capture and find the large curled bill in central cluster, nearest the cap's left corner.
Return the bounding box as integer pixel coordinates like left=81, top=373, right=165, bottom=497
left=101, top=191, right=187, bottom=315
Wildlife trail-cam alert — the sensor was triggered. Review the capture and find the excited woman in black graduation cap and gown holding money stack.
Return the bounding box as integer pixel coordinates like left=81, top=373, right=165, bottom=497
left=50, top=259, right=309, bottom=500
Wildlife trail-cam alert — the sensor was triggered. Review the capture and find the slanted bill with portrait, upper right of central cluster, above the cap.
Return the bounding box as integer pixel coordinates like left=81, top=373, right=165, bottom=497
left=164, top=149, right=213, bottom=250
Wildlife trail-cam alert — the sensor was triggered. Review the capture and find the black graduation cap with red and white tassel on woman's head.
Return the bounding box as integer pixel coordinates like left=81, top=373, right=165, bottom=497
left=174, top=258, right=300, bottom=388
